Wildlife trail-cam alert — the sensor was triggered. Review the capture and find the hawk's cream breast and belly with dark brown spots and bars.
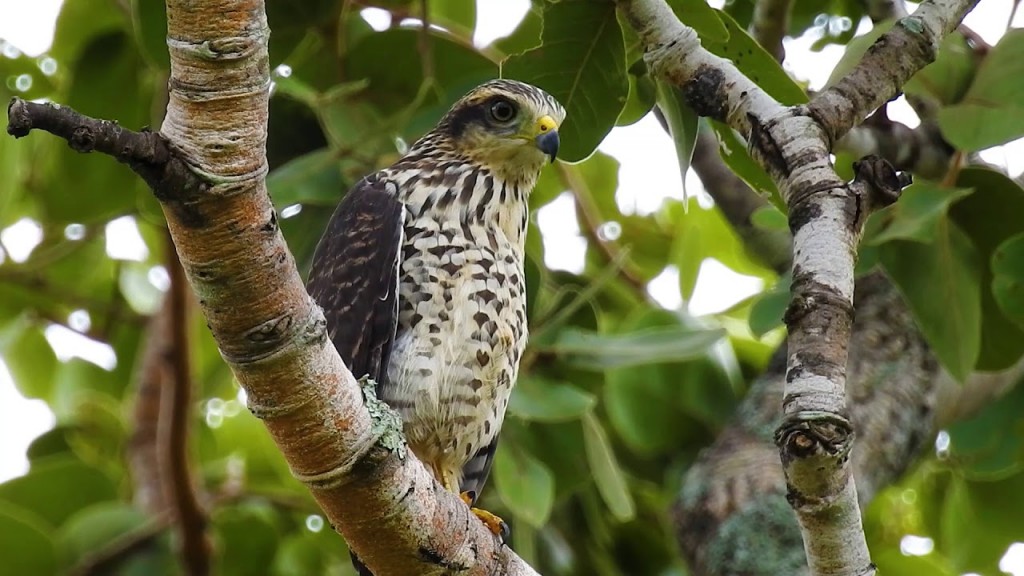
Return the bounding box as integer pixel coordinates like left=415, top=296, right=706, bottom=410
left=383, top=165, right=526, bottom=490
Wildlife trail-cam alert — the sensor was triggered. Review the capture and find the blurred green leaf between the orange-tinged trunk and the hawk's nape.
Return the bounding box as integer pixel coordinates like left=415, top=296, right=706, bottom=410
left=266, top=149, right=344, bottom=209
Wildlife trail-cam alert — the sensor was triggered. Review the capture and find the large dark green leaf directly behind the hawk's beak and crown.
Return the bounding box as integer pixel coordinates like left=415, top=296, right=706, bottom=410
left=502, top=0, right=629, bottom=162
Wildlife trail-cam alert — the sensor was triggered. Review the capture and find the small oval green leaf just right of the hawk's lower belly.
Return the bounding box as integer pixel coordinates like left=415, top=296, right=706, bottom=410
left=509, top=376, right=597, bottom=422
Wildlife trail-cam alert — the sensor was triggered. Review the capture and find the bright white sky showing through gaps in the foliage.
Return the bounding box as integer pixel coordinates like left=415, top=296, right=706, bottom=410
left=0, top=5, right=1024, bottom=565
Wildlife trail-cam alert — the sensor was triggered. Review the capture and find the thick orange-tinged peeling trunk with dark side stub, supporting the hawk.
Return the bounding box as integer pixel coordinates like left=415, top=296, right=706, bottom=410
left=8, top=0, right=536, bottom=576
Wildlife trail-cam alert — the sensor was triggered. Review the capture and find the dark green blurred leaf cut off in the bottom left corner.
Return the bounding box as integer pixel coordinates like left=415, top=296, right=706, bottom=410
left=0, top=498, right=57, bottom=576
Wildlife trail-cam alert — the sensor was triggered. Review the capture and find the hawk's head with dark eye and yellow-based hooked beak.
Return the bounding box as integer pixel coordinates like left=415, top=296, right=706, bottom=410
left=436, top=80, right=565, bottom=179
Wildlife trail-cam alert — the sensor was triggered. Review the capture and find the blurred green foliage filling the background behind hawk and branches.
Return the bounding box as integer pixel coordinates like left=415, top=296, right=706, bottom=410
left=0, top=0, right=1024, bottom=575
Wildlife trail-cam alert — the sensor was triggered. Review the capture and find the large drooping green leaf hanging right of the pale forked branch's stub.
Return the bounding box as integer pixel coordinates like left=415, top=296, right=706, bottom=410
left=880, top=218, right=981, bottom=382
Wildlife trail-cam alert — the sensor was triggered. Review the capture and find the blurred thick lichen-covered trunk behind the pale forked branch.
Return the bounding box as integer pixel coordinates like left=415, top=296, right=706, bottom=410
left=673, top=274, right=1024, bottom=576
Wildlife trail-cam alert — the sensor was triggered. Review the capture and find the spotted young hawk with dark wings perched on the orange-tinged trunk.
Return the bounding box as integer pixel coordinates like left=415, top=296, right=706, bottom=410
left=307, top=80, right=565, bottom=574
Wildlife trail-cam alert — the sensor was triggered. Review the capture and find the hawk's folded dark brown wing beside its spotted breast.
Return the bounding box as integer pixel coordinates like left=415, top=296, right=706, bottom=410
left=306, top=176, right=404, bottom=389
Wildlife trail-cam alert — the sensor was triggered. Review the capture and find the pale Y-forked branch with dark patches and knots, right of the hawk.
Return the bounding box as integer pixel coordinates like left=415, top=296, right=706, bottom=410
left=620, top=0, right=975, bottom=575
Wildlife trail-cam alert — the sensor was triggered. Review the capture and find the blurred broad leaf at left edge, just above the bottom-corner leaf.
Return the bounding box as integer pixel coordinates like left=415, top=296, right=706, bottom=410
left=0, top=455, right=117, bottom=526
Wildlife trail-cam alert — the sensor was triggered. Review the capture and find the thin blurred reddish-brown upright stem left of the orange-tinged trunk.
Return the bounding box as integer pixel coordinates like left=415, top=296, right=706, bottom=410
left=157, top=242, right=211, bottom=576
